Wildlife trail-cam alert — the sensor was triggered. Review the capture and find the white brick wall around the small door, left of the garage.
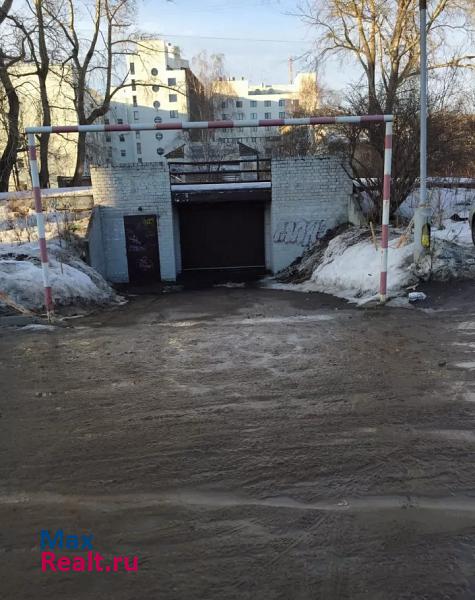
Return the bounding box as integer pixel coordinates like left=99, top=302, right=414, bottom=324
left=90, top=161, right=177, bottom=283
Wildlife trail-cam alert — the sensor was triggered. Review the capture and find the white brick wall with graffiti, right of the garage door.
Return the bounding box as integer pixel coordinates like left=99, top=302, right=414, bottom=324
left=271, top=156, right=352, bottom=273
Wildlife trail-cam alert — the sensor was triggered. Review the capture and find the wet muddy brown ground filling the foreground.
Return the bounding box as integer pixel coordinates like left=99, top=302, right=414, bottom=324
left=0, top=284, right=475, bottom=600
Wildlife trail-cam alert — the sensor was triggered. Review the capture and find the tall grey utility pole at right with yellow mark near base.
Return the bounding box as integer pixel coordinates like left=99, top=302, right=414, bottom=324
left=414, top=0, right=431, bottom=262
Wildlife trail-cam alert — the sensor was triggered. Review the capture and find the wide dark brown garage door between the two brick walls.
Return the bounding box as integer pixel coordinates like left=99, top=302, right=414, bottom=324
left=180, top=201, right=265, bottom=271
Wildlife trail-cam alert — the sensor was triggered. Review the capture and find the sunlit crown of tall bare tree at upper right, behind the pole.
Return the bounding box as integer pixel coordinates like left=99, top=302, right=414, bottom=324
left=300, top=0, right=475, bottom=113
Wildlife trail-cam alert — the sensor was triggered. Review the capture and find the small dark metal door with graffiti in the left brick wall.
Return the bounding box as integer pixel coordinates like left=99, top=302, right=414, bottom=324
left=124, top=215, right=160, bottom=283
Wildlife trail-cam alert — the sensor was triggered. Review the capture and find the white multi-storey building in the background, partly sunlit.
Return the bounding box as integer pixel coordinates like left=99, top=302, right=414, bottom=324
left=106, top=40, right=317, bottom=165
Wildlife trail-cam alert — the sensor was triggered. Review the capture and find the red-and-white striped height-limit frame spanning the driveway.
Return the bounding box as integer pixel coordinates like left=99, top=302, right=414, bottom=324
left=25, top=115, right=393, bottom=318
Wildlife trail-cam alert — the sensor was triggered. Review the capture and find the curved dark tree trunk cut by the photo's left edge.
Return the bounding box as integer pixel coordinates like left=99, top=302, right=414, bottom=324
left=0, top=50, right=20, bottom=192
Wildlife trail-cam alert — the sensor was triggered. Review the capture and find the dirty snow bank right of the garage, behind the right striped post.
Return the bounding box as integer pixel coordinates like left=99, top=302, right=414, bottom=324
left=270, top=223, right=475, bottom=304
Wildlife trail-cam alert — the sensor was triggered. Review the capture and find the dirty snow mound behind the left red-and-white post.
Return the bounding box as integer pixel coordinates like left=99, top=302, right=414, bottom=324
left=0, top=241, right=118, bottom=310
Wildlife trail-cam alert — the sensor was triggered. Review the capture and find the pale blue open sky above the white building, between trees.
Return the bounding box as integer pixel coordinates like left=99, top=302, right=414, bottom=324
left=139, top=0, right=355, bottom=89
